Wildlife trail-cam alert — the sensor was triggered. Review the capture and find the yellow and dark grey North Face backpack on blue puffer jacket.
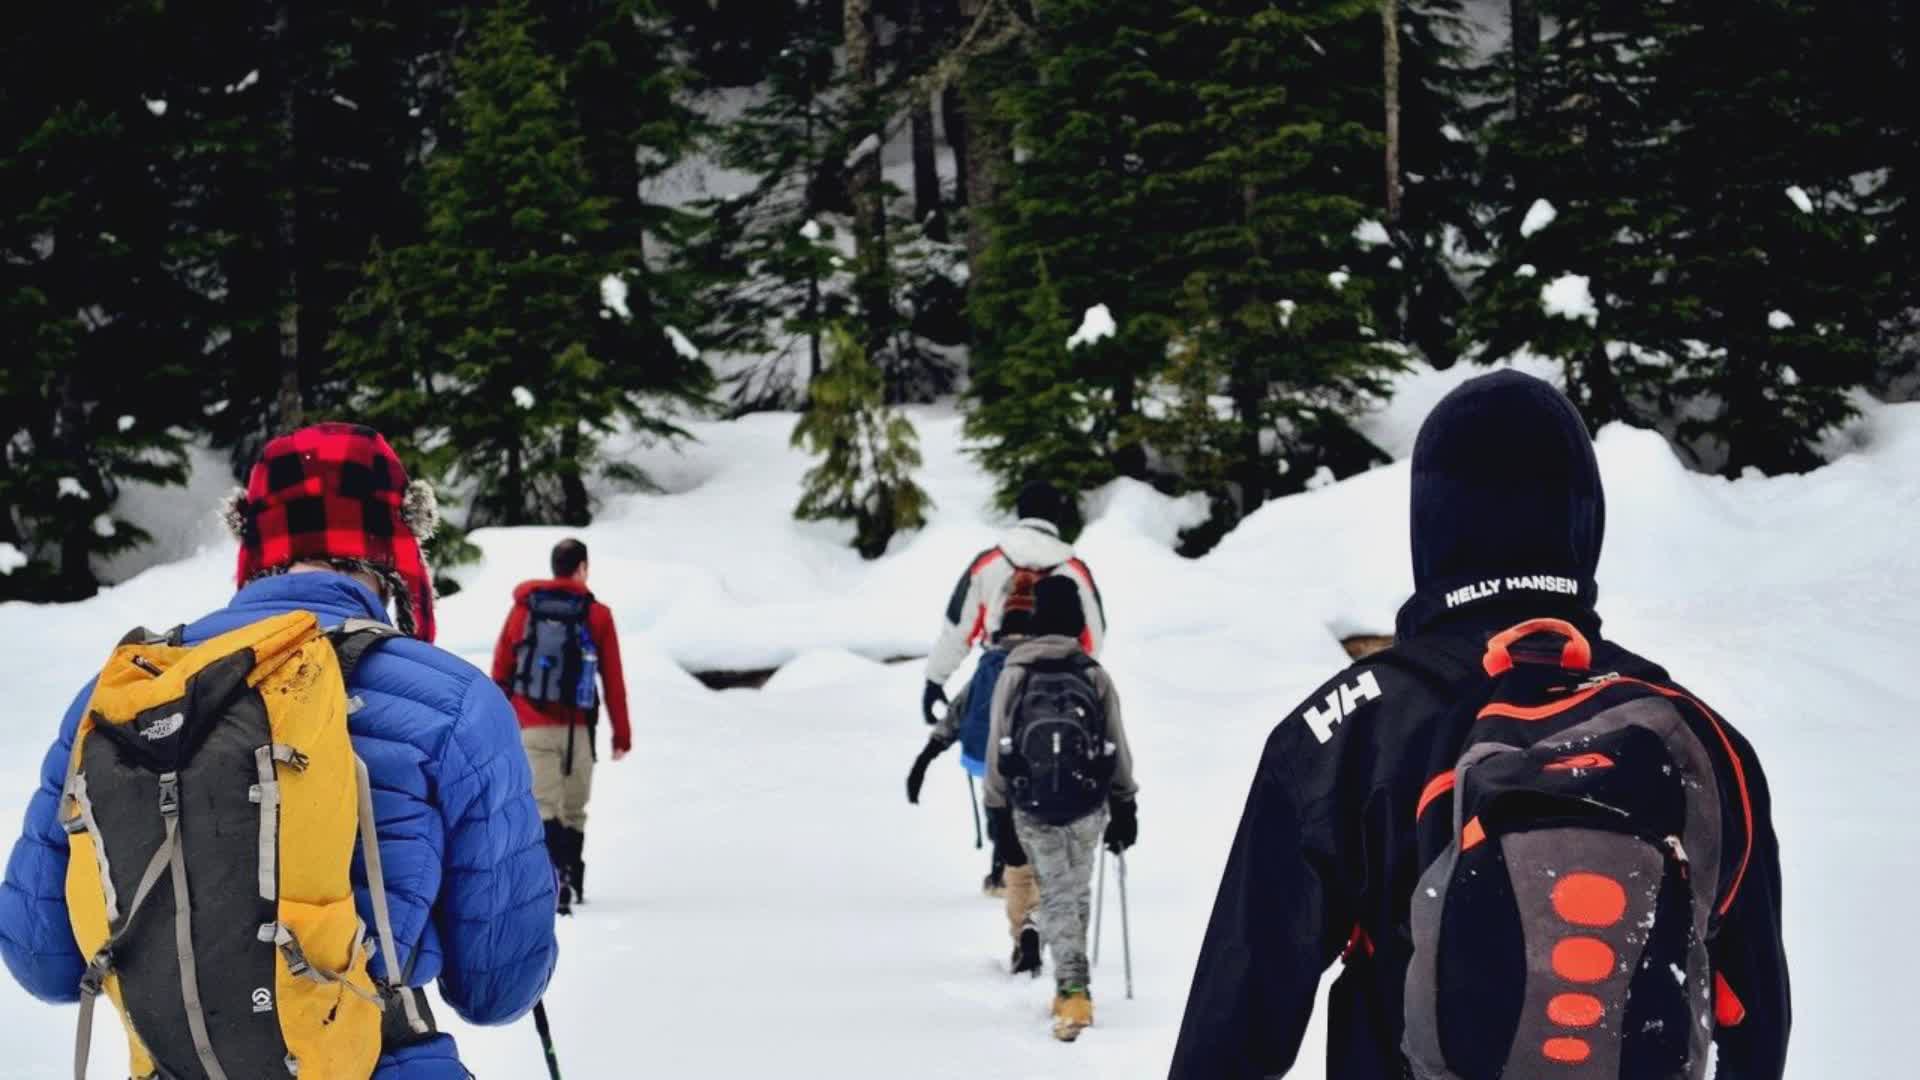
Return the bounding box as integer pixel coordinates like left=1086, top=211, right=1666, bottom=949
left=61, top=611, right=432, bottom=1080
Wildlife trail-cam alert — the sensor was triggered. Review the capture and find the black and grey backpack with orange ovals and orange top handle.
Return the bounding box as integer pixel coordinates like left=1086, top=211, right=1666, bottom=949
left=1402, top=619, right=1751, bottom=1080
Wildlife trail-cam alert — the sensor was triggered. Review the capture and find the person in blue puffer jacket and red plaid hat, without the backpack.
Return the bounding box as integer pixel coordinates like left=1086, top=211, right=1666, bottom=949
left=0, top=425, right=559, bottom=1080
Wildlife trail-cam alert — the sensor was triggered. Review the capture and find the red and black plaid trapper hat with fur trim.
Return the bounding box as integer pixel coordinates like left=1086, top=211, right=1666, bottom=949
left=230, top=423, right=434, bottom=642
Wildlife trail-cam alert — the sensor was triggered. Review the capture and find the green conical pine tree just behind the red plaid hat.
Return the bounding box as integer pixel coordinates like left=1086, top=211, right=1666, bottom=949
left=334, top=0, right=708, bottom=527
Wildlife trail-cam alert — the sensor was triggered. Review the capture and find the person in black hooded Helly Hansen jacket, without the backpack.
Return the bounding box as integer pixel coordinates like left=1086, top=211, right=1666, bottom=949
left=1169, top=371, right=1791, bottom=1080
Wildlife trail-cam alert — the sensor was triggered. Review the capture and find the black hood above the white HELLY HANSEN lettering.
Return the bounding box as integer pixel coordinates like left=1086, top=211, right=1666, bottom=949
left=1411, top=371, right=1607, bottom=590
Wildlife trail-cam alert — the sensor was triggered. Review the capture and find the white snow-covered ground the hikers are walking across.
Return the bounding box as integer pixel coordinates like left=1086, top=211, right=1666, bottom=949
left=0, top=363, right=1920, bottom=1080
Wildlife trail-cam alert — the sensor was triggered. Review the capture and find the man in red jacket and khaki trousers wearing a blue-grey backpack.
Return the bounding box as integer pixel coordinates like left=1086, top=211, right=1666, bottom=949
left=493, top=540, right=634, bottom=915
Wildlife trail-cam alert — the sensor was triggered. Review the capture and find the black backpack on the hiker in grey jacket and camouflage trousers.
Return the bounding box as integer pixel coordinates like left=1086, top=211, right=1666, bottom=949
left=1000, top=653, right=1116, bottom=824
